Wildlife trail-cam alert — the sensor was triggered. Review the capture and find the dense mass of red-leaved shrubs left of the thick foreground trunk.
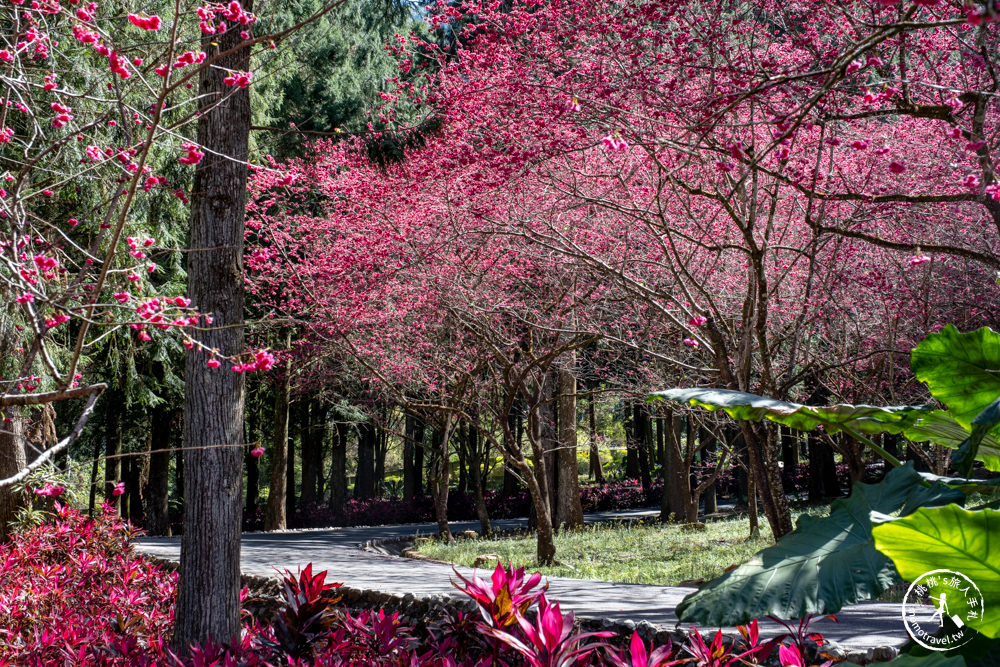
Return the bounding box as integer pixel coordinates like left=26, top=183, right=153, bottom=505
left=0, top=502, right=177, bottom=665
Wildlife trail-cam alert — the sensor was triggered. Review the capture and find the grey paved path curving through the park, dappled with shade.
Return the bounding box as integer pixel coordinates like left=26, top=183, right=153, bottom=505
left=139, top=510, right=907, bottom=650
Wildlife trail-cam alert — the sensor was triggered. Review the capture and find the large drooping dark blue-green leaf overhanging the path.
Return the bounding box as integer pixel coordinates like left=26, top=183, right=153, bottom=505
left=677, top=463, right=965, bottom=626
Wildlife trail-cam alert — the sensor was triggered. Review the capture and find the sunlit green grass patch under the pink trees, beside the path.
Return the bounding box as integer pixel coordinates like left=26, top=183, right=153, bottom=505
left=418, top=506, right=829, bottom=586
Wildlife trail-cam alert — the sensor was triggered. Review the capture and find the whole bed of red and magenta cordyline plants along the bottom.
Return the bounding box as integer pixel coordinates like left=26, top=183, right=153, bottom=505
left=0, top=508, right=822, bottom=667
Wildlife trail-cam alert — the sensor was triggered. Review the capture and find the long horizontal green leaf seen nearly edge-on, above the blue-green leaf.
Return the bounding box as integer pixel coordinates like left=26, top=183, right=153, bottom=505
left=650, top=387, right=1000, bottom=471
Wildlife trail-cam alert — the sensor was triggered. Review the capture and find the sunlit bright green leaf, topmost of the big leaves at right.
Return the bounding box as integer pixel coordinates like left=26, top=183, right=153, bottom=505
left=910, top=324, right=1000, bottom=430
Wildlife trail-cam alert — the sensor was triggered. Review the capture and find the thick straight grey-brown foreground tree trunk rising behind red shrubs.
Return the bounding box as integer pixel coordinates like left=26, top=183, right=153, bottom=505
left=173, top=6, right=253, bottom=654
